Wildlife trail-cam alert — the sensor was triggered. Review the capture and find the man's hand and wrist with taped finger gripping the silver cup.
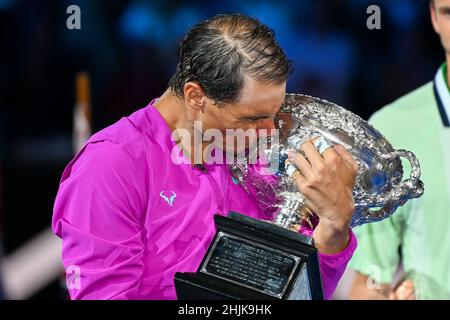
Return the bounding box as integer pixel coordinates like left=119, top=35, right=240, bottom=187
left=290, top=141, right=358, bottom=254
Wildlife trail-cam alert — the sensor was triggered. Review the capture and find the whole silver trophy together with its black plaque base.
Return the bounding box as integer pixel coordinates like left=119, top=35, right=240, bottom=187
left=175, top=94, right=424, bottom=300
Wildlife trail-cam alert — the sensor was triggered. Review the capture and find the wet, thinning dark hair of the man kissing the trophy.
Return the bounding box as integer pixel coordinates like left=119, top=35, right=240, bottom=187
left=169, top=15, right=294, bottom=104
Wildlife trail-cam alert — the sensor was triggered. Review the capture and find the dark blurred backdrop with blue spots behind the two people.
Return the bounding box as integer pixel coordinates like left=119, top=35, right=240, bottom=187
left=0, top=0, right=444, bottom=299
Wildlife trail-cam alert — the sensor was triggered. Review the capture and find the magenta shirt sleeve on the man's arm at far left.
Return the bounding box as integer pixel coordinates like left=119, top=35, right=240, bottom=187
left=52, top=141, right=144, bottom=299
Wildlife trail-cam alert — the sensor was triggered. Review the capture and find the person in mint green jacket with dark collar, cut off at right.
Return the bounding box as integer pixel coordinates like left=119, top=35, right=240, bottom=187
left=349, top=0, right=450, bottom=299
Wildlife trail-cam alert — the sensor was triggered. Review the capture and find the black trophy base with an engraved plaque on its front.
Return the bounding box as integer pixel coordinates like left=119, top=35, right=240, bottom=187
left=174, top=212, right=323, bottom=300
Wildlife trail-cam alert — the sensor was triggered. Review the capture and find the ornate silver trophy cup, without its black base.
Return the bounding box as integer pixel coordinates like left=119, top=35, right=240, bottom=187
left=231, top=94, right=424, bottom=228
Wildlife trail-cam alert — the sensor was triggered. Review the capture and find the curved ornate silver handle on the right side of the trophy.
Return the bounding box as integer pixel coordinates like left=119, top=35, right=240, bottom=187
left=351, top=150, right=424, bottom=227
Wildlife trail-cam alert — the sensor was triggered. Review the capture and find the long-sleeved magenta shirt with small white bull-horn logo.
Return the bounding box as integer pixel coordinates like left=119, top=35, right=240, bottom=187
left=52, top=103, right=356, bottom=299
